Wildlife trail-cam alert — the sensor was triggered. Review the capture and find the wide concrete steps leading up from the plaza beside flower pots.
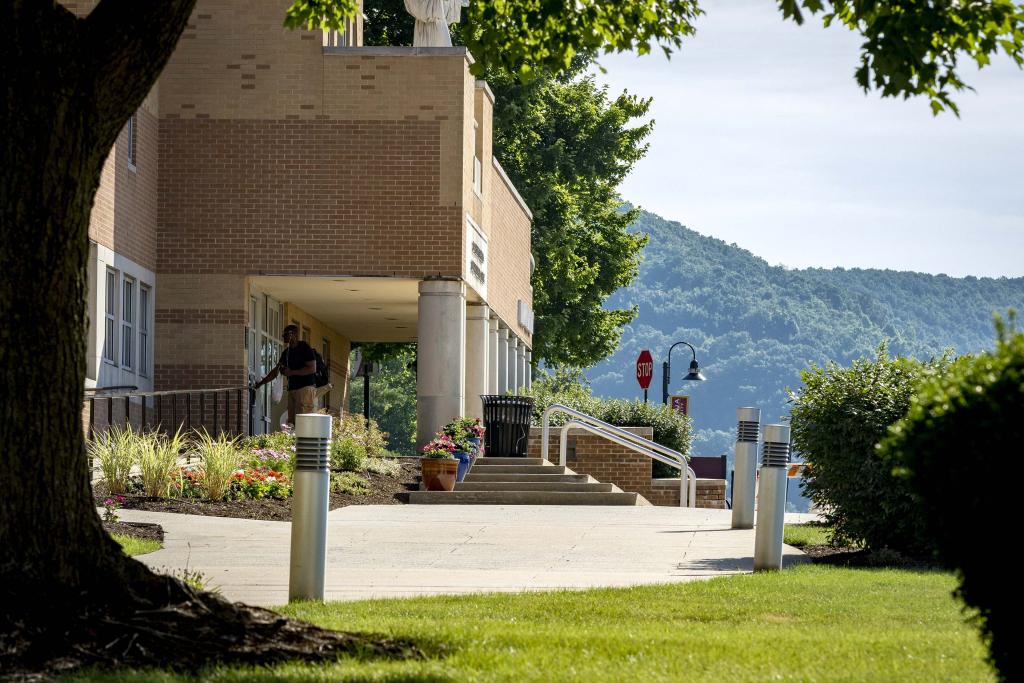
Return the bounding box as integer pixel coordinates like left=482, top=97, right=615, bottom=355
left=409, top=458, right=650, bottom=505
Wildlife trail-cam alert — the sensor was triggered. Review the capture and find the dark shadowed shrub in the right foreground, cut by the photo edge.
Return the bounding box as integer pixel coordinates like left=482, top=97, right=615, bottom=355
left=882, top=317, right=1024, bottom=681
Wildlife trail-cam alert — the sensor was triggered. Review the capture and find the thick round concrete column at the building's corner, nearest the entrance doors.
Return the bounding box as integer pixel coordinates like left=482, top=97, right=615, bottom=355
left=416, top=280, right=466, bottom=449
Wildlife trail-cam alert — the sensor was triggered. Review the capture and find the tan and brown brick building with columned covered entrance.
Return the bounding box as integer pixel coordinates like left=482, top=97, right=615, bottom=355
left=77, top=0, right=532, bottom=448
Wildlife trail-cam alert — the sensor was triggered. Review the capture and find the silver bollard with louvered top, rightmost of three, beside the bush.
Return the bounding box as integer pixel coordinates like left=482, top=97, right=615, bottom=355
left=754, top=425, right=790, bottom=571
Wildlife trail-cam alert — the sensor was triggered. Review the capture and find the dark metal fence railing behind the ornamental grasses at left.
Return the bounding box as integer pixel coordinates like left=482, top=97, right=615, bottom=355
left=83, top=386, right=256, bottom=439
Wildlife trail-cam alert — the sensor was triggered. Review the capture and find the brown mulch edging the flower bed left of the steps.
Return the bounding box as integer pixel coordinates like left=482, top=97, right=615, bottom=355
left=93, top=459, right=420, bottom=532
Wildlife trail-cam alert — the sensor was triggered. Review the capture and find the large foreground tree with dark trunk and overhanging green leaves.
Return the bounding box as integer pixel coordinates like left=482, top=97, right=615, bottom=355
left=0, top=0, right=1024, bottom=669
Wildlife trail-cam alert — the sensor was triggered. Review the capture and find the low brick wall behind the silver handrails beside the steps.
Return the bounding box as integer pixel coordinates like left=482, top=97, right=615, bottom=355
left=528, top=427, right=725, bottom=509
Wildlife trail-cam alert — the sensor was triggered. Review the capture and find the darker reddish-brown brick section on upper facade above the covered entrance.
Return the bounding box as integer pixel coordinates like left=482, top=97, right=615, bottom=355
left=157, top=119, right=463, bottom=278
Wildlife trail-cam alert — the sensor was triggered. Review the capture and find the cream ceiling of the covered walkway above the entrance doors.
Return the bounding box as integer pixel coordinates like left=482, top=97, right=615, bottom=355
left=249, top=275, right=420, bottom=342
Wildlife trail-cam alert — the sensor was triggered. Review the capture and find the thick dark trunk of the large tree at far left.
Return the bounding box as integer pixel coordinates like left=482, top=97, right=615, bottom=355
left=0, top=0, right=195, bottom=592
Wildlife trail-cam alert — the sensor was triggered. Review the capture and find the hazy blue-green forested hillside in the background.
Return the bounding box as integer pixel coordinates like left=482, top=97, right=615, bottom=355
left=587, top=212, right=1024, bottom=455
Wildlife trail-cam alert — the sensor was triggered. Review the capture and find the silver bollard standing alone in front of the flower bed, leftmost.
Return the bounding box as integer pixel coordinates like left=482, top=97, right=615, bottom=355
left=288, top=415, right=331, bottom=601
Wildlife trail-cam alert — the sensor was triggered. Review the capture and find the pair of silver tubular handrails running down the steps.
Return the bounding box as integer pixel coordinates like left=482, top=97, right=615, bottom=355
left=541, top=403, right=697, bottom=508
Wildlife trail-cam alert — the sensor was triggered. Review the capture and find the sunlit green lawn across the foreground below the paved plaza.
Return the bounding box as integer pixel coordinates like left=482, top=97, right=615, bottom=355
left=59, top=565, right=994, bottom=683
